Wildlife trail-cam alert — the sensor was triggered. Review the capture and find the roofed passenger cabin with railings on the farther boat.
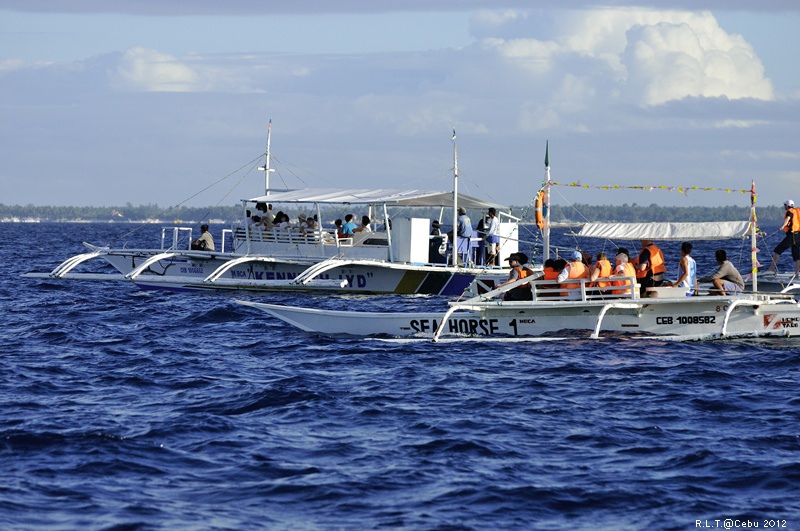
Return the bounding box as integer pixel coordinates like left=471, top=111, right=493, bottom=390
left=232, top=189, right=519, bottom=266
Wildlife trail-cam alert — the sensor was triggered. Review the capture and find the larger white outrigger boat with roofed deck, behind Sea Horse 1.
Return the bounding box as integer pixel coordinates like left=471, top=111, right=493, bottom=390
left=25, top=127, right=519, bottom=296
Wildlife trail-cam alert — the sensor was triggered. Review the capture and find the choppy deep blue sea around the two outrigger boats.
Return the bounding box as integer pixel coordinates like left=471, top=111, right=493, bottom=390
left=0, top=223, right=800, bottom=530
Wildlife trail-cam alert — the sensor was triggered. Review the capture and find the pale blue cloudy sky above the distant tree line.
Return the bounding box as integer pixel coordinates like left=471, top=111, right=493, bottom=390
left=0, top=0, right=800, bottom=212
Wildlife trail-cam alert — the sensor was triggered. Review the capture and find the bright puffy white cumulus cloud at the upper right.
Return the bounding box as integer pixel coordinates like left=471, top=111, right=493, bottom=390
left=482, top=8, right=774, bottom=110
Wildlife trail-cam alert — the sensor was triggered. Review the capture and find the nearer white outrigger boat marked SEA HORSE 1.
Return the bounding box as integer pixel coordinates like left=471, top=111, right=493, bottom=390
left=237, top=157, right=800, bottom=341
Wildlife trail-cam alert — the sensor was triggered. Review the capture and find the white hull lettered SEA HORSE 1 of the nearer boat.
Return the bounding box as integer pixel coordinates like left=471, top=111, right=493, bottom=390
left=237, top=297, right=800, bottom=339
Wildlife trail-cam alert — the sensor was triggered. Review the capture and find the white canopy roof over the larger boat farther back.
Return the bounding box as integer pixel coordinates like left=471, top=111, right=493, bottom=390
left=248, top=188, right=507, bottom=210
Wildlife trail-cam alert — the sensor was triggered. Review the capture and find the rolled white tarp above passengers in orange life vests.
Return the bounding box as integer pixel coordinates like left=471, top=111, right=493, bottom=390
left=577, top=221, right=750, bottom=241
